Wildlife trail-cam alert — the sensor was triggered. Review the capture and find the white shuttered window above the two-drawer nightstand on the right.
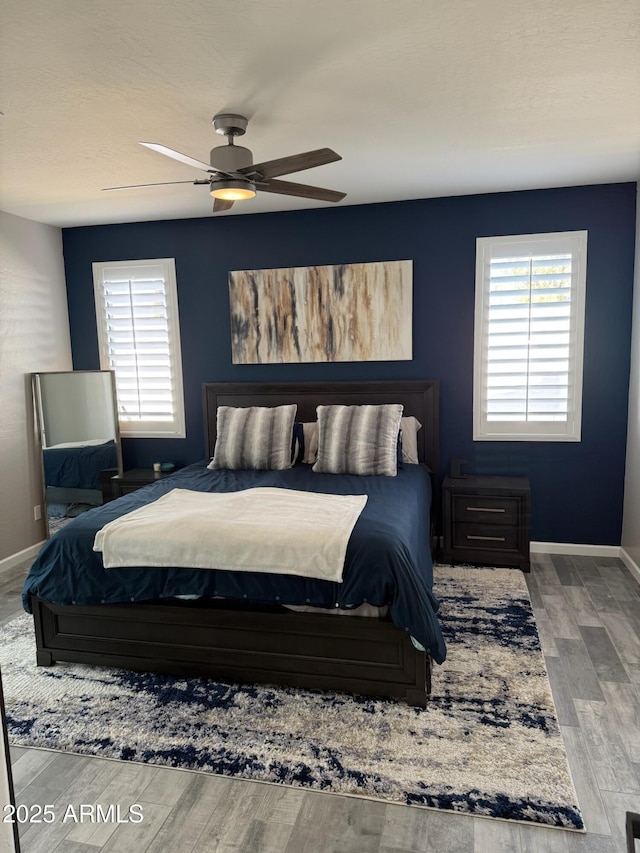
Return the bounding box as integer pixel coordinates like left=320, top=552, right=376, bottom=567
left=473, top=231, right=587, bottom=441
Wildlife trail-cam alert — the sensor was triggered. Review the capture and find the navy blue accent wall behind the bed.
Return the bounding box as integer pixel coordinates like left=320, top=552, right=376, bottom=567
left=63, top=183, right=636, bottom=545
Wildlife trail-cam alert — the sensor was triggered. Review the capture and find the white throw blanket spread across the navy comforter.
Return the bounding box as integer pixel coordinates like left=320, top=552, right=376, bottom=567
left=93, top=488, right=367, bottom=581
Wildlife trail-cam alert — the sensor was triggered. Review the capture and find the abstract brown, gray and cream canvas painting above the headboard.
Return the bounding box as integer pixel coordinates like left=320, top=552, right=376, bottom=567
left=229, top=261, right=413, bottom=364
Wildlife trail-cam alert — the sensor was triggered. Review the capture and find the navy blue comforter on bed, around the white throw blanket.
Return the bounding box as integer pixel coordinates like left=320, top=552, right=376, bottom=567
left=23, top=462, right=446, bottom=663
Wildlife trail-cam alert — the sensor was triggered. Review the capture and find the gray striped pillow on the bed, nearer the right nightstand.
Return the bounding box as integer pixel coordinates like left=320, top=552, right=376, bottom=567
left=313, top=403, right=402, bottom=477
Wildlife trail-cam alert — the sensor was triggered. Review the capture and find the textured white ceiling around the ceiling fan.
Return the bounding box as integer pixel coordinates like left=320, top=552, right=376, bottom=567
left=0, top=0, right=640, bottom=226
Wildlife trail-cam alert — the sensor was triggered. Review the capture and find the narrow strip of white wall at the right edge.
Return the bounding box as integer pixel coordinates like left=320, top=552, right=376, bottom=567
left=622, top=183, right=640, bottom=566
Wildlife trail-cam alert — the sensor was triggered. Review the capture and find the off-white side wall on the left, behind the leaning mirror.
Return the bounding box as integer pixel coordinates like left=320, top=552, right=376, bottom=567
left=0, top=211, right=71, bottom=560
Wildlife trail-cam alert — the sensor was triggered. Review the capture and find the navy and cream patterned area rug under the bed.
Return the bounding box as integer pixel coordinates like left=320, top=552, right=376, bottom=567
left=0, top=567, right=583, bottom=830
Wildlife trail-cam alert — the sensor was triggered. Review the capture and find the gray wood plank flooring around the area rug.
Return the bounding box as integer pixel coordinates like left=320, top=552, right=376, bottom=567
left=0, top=554, right=640, bottom=853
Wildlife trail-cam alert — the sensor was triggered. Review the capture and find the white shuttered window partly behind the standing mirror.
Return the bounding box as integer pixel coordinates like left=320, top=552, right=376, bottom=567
left=93, top=258, right=185, bottom=438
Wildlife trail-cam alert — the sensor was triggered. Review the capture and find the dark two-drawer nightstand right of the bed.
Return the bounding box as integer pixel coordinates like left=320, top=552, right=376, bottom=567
left=442, top=475, right=531, bottom=572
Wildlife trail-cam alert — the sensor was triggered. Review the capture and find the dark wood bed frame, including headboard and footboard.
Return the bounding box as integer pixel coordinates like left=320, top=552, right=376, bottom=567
left=31, top=380, right=439, bottom=707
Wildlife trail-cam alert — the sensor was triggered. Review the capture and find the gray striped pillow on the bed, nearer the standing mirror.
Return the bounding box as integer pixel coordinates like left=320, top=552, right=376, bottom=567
left=207, top=404, right=298, bottom=471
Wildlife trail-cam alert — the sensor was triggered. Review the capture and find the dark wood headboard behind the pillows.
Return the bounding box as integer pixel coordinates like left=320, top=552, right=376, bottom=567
left=202, top=379, right=440, bottom=478
